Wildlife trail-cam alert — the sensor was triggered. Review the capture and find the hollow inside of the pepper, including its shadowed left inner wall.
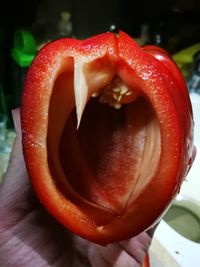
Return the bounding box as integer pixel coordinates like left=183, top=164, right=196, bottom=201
left=48, top=59, right=161, bottom=218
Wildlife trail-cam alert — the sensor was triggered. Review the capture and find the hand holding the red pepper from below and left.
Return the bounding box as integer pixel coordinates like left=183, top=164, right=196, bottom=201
left=0, top=109, right=153, bottom=267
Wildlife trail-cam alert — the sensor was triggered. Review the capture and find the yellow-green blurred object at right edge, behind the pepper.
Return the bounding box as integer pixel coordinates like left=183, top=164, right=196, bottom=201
left=172, top=43, right=200, bottom=78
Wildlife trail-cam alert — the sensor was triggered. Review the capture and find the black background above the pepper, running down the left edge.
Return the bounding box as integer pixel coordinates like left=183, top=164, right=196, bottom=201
left=0, top=0, right=200, bottom=125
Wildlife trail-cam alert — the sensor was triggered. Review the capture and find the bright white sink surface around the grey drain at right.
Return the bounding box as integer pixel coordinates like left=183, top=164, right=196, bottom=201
left=150, top=94, right=200, bottom=267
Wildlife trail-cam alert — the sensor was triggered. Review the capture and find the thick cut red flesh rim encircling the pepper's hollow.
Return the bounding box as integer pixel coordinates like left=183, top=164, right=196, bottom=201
left=21, top=32, right=194, bottom=244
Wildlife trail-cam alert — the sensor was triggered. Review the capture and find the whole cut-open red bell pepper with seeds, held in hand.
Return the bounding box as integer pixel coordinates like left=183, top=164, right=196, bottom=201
left=21, top=32, right=194, bottom=244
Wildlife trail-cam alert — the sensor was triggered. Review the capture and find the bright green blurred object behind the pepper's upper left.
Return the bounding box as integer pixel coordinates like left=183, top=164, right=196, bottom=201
left=11, top=29, right=37, bottom=67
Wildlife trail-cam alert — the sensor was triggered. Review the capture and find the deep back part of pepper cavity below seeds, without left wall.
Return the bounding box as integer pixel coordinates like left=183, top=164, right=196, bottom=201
left=59, top=98, right=159, bottom=214
